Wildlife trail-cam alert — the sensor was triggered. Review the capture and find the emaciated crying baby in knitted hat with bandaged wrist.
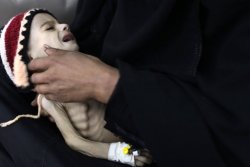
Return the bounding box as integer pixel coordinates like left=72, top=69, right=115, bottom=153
left=0, top=9, right=151, bottom=166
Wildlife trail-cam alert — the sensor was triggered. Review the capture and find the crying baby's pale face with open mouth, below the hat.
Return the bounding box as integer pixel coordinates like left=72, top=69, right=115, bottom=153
left=28, top=13, right=78, bottom=58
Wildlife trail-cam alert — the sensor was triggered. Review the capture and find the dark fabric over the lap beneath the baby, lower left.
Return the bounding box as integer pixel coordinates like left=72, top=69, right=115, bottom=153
left=0, top=50, right=129, bottom=167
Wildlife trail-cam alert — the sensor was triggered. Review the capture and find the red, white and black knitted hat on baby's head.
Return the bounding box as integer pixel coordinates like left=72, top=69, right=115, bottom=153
left=0, top=9, right=54, bottom=89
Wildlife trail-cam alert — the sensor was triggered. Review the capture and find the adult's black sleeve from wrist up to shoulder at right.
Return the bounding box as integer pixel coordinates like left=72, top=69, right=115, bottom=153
left=107, top=0, right=250, bottom=167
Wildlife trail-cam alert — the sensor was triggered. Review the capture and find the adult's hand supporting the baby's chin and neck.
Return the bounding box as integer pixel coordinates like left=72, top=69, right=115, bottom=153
left=28, top=46, right=119, bottom=103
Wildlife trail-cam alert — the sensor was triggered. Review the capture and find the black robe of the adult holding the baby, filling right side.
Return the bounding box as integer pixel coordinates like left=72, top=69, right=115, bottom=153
left=72, top=0, right=250, bottom=167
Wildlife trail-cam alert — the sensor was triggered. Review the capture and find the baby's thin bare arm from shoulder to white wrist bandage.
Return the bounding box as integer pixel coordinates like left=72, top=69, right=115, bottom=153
left=38, top=95, right=109, bottom=159
